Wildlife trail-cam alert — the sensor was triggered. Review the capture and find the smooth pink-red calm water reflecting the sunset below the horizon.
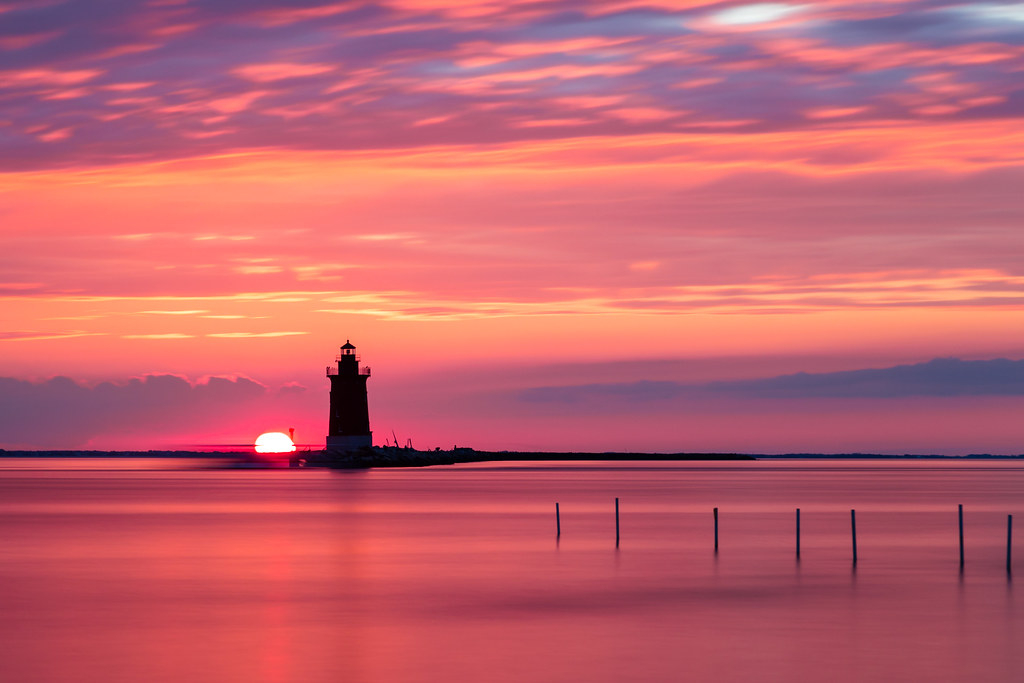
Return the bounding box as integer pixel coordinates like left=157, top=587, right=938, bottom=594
left=0, top=461, right=1024, bottom=683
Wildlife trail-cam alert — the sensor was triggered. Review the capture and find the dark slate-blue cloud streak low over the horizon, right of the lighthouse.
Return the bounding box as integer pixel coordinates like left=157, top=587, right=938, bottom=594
left=520, top=358, right=1024, bottom=408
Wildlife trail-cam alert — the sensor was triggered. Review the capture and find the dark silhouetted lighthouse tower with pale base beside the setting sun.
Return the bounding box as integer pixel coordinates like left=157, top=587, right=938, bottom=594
left=327, top=340, right=373, bottom=452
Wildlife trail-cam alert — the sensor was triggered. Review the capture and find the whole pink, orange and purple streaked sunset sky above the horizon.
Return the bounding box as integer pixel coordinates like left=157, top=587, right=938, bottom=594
left=0, top=0, right=1024, bottom=455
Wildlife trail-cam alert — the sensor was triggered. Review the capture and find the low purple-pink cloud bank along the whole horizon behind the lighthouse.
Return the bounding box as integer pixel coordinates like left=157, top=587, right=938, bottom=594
left=0, top=358, right=1024, bottom=453
